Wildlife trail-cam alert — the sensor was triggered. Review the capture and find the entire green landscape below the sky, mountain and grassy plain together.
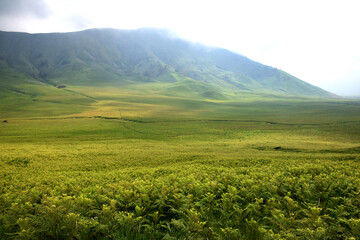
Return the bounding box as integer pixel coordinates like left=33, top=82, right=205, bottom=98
left=0, top=29, right=360, bottom=239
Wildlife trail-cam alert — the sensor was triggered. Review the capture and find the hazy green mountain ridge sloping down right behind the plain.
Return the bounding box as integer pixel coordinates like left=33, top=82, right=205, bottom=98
left=0, top=29, right=335, bottom=100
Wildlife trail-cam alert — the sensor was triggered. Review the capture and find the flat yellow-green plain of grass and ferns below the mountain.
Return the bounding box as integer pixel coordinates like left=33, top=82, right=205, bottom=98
left=0, top=83, right=360, bottom=239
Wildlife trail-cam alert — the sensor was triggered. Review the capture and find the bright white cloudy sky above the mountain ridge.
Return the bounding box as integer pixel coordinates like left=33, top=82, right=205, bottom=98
left=0, top=0, right=360, bottom=96
